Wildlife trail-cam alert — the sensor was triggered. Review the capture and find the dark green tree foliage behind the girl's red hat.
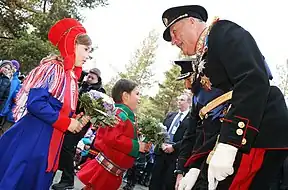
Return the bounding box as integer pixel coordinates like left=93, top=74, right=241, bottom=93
left=0, top=0, right=107, bottom=73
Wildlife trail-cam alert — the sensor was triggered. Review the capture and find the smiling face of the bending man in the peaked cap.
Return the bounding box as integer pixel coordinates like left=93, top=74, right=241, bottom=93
left=170, top=17, right=198, bottom=56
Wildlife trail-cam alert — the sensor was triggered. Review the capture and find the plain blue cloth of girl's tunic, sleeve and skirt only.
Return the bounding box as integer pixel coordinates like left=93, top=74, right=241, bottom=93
left=0, top=88, right=62, bottom=190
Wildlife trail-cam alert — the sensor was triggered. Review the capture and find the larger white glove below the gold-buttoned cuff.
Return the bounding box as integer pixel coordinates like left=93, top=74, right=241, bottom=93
left=208, top=143, right=238, bottom=190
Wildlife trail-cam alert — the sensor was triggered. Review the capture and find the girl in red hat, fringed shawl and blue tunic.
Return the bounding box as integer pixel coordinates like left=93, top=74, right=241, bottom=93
left=0, top=19, right=91, bottom=190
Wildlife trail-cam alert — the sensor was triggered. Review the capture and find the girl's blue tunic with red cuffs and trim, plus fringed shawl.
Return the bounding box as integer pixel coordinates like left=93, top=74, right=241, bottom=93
left=0, top=60, right=77, bottom=190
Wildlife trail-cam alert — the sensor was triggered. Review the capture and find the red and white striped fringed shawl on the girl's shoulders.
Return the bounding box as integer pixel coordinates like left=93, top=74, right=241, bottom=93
left=13, top=56, right=78, bottom=121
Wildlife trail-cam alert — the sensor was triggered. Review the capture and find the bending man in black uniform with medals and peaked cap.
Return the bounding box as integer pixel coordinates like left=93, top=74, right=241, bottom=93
left=162, top=5, right=288, bottom=190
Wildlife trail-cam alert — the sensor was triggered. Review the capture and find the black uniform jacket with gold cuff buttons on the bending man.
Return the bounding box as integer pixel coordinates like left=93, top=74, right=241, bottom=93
left=186, top=20, right=288, bottom=168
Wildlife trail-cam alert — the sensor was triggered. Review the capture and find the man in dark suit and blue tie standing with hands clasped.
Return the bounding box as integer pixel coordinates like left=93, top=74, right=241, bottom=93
left=149, top=93, right=191, bottom=190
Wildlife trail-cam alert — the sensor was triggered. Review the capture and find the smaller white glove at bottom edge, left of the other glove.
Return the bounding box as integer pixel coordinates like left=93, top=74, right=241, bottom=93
left=178, top=168, right=200, bottom=190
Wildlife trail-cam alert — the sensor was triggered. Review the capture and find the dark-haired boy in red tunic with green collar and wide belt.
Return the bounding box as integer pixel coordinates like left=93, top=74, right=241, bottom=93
left=77, top=79, right=146, bottom=190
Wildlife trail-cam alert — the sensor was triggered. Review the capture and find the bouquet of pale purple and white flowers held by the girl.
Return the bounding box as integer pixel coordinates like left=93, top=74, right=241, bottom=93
left=80, top=90, right=118, bottom=127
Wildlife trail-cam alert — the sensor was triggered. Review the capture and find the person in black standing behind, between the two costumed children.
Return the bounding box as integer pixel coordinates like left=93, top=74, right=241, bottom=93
left=52, top=68, right=105, bottom=190
